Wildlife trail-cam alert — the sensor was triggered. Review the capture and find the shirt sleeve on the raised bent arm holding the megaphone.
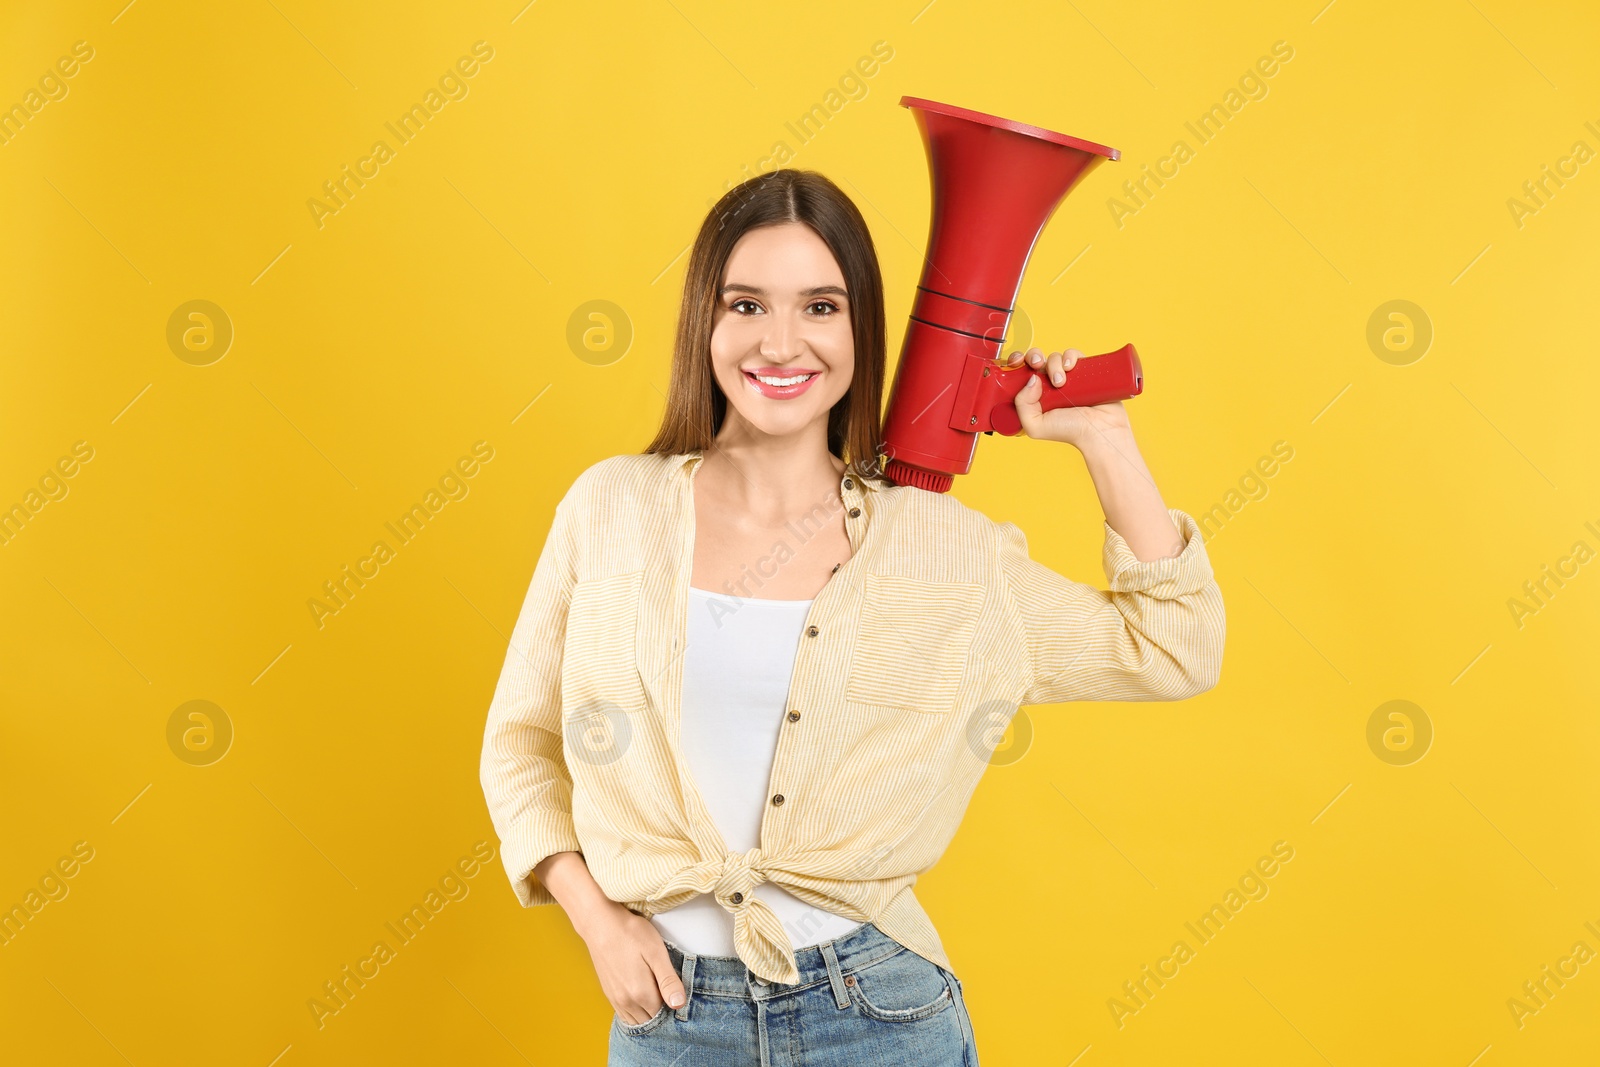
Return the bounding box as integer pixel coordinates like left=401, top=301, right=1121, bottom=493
left=998, top=509, right=1227, bottom=704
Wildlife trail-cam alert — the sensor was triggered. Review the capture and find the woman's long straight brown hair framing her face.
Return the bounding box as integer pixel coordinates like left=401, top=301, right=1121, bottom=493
left=645, top=168, right=886, bottom=485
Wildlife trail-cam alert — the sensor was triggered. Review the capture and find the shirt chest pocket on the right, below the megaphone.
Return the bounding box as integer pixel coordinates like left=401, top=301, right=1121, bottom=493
left=845, top=574, right=984, bottom=713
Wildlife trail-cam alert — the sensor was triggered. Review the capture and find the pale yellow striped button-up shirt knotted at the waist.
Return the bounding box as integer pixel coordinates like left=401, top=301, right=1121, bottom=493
left=480, top=451, right=1224, bottom=982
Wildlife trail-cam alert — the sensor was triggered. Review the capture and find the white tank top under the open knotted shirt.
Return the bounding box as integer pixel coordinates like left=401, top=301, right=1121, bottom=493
left=650, top=587, right=861, bottom=957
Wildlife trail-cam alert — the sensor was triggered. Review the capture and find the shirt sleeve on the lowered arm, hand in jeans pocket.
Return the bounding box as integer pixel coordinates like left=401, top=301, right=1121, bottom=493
left=478, top=491, right=581, bottom=907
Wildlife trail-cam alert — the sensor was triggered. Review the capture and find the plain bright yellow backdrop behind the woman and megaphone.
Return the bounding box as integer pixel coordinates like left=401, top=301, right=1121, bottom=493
left=0, top=0, right=1600, bottom=1067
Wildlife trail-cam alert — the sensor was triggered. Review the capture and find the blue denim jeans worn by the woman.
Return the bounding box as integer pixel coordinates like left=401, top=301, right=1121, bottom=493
left=606, top=923, right=978, bottom=1067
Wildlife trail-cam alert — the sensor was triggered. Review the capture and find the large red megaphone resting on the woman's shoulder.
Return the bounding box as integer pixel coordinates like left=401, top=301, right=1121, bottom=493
left=883, top=96, right=1144, bottom=493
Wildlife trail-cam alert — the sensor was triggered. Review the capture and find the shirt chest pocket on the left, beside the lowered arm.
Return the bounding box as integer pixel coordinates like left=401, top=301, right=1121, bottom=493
left=562, top=571, right=645, bottom=720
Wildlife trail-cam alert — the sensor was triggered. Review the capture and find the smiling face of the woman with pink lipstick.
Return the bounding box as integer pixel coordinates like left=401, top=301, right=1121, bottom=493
left=710, top=222, right=856, bottom=440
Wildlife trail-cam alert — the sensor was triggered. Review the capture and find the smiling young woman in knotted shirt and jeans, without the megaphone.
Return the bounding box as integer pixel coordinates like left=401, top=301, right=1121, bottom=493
left=482, top=170, right=1224, bottom=1067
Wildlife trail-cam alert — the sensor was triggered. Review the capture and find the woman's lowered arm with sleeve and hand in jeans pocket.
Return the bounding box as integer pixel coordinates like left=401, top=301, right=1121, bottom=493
left=478, top=477, right=683, bottom=1024
